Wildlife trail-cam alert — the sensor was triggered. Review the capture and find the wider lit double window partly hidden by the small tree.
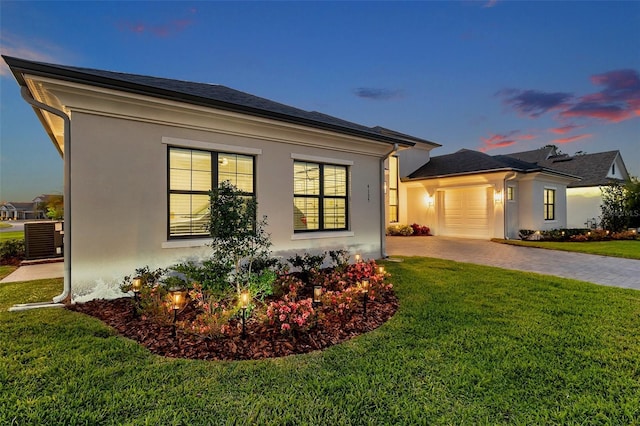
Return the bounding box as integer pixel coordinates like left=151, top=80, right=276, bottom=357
left=168, top=147, right=255, bottom=238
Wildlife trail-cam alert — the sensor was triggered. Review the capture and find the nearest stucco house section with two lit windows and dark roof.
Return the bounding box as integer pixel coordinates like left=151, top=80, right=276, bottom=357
left=4, top=57, right=439, bottom=302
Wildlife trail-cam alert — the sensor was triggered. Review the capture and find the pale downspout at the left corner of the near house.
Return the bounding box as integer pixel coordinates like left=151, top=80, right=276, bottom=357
left=20, top=86, right=71, bottom=306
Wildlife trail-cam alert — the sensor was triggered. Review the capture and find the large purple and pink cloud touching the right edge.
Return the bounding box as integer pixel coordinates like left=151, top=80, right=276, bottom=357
left=560, top=69, right=640, bottom=123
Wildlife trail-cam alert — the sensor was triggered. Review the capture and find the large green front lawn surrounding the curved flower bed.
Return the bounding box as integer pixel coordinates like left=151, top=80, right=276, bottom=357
left=0, top=258, right=640, bottom=425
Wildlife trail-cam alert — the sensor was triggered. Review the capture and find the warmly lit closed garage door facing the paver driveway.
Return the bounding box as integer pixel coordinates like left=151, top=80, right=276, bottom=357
left=439, top=187, right=491, bottom=238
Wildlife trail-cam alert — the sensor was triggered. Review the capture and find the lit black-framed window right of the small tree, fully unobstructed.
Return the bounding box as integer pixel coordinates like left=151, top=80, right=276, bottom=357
left=293, top=161, right=348, bottom=232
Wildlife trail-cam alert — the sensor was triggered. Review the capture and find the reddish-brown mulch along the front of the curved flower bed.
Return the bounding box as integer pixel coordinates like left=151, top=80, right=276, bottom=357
left=67, top=292, right=398, bottom=360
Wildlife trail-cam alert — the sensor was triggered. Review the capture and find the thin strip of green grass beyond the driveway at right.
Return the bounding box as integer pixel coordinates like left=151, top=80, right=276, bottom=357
left=492, top=238, right=640, bottom=259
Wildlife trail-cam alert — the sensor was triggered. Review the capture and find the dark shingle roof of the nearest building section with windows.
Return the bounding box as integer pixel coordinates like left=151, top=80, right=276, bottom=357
left=3, top=56, right=439, bottom=146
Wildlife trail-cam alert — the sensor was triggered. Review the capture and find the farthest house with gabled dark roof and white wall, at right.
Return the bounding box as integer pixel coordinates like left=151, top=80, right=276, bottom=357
left=507, top=146, right=629, bottom=228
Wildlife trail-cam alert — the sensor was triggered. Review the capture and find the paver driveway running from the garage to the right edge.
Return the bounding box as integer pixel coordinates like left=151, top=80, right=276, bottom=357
left=387, top=237, right=640, bottom=290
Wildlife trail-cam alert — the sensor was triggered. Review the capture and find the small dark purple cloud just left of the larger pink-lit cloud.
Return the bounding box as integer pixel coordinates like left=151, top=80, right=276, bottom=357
left=497, top=89, right=573, bottom=118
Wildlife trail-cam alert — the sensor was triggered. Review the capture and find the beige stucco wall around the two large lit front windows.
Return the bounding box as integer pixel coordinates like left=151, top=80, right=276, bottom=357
left=69, top=112, right=386, bottom=300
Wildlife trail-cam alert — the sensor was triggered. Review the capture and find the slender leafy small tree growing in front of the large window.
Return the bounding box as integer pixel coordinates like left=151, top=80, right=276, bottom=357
left=209, top=181, right=271, bottom=293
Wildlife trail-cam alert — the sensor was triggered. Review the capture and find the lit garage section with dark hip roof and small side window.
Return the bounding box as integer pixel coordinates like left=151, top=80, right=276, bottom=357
left=389, top=149, right=578, bottom=239
